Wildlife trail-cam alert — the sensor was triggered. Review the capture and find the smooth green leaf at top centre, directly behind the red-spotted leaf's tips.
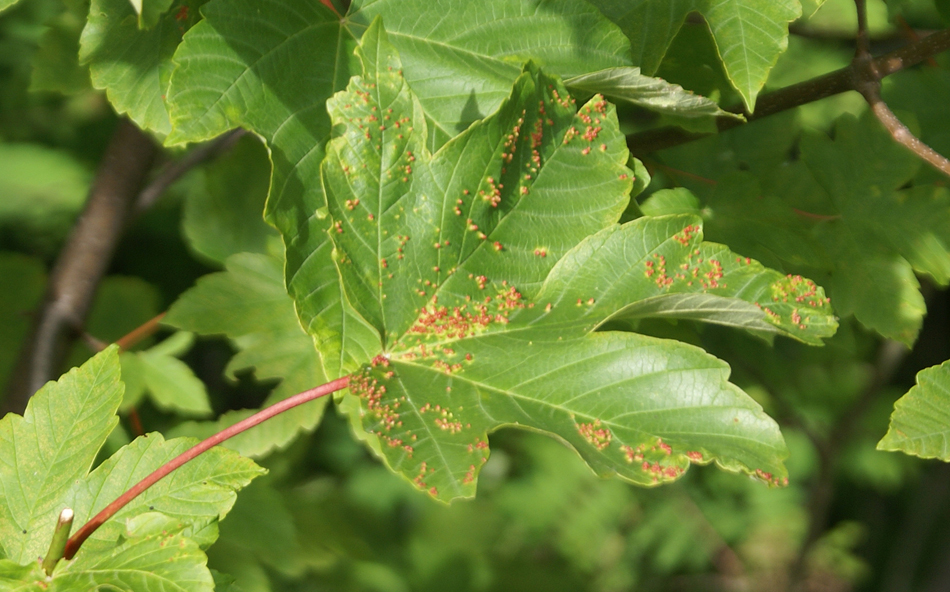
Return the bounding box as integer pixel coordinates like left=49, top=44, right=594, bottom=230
left=348, top=0, right=630, bottom=150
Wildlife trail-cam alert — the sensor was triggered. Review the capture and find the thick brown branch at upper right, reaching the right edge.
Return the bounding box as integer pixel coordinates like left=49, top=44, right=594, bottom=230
left=627, top=29, right=950, bottom=156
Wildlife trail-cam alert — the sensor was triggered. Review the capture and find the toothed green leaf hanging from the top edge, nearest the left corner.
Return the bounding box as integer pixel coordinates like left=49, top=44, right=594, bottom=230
left=79, top=0, right=205, bottom=136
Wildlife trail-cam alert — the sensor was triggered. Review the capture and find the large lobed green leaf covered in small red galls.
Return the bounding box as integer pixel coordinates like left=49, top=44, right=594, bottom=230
left=308, top=21, right=834, bottom=501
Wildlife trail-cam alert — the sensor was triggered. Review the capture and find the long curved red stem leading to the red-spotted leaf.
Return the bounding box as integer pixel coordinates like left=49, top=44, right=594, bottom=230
left=63, top=376, right=350, bottom=559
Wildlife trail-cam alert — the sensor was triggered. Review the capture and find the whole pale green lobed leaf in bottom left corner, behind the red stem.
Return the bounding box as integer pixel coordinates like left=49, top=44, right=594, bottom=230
left=0, top=346, right=263, bottom=572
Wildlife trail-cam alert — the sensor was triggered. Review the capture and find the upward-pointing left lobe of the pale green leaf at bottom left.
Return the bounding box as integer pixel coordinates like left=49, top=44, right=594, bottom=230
left=0, top=347, right=123, bottom=563
